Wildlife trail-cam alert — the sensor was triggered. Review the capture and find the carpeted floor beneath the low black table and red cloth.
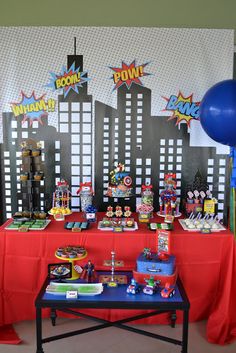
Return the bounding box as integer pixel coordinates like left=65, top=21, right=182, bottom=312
left=0, top=318, right=236, bottom=353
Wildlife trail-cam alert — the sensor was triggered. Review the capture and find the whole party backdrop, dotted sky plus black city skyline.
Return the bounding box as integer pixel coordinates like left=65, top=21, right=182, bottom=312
left=0, top=27, right=234, bottom=221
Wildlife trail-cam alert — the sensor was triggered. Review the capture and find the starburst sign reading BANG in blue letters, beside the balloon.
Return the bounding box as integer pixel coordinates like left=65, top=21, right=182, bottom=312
left=163, top=91, right=200, bottom=127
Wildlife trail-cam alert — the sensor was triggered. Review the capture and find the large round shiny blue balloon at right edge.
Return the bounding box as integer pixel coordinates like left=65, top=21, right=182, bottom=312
left=199, top=80, right=236, bottom=147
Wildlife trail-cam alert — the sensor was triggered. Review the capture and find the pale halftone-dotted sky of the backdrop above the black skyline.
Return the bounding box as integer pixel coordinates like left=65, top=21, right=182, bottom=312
left=0, top=27, right=233, bottom=140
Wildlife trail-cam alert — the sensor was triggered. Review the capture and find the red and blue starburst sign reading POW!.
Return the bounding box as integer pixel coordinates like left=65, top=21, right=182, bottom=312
left=110, top=60, right=151, bottom=91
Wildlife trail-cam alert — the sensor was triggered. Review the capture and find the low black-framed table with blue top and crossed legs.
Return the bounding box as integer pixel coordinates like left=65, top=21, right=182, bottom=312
left=35, top=272, right=189, bottom=353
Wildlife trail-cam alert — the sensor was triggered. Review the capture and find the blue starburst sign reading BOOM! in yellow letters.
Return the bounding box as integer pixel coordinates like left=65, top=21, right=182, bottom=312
left=46, top=63, right=91, bottom=97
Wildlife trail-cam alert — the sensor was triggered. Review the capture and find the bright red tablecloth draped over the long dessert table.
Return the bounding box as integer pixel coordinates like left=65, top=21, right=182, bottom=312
left=0, top=214, right=236, bottom=344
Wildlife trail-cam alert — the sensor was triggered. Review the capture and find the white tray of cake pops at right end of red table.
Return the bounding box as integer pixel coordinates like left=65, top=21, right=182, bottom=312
left=178, top=218, right=226, bottom=232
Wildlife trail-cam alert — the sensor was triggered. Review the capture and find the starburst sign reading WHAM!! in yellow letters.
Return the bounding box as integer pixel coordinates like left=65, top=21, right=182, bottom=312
left=11, top=91, right=56, bottom=125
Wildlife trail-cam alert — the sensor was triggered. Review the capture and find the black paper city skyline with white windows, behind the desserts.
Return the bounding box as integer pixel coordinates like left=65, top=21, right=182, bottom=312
left=0, top=49, right=229, bottom=222
